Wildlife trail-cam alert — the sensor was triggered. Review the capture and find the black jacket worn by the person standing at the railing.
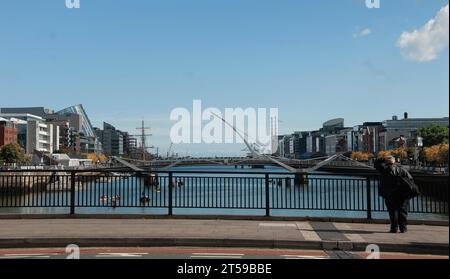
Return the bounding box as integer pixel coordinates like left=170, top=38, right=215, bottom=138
left=375, top=159, right=413, bottom=199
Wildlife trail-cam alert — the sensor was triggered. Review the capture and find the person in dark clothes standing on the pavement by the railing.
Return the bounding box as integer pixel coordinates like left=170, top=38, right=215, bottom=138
left=374, top=156, right=419, bottom=233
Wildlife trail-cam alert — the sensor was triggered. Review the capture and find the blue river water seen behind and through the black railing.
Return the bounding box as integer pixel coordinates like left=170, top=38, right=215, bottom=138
left=0, top=166, right=448, bottom=220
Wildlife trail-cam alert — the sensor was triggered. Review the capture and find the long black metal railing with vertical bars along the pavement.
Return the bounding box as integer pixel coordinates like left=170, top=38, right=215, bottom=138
left=0, top=170, right=448, bottom=219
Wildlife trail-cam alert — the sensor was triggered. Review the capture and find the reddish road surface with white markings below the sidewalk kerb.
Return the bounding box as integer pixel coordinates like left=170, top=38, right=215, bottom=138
left=0, top=247, right=449, bottom=260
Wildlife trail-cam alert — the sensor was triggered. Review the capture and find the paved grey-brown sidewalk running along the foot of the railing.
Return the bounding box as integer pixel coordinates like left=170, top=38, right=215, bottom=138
left=0, top=219, right=449, bottom=255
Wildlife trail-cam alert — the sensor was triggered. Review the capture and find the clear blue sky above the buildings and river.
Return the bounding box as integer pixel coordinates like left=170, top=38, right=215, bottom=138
left=0, top=0, right=449, bottom=156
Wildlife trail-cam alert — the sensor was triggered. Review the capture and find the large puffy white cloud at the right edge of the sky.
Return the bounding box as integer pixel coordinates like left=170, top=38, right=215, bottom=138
left=397, top=4, right=449, bottom=62
